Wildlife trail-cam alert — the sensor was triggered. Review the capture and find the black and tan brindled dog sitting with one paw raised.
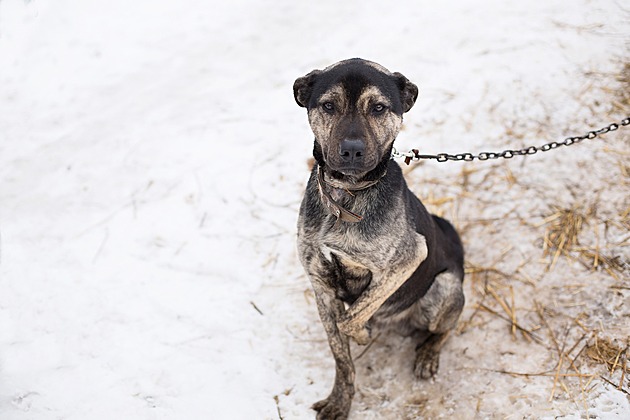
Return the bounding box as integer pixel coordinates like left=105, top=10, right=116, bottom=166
left=293, top=58, right=464, bottom=420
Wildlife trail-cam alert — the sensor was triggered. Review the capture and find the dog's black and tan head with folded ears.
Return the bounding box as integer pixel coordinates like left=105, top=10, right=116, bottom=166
left=293, top=58, right=418, bottom=179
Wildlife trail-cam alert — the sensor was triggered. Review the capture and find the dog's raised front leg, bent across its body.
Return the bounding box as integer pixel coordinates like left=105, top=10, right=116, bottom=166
left=337, top=234, right=427, bottom=344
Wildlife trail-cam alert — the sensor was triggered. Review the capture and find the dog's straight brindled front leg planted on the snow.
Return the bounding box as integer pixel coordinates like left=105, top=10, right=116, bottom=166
left=313, top=282, right=354, bottom=420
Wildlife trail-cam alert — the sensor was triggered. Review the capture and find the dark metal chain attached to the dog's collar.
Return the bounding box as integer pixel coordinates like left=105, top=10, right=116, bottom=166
left=392, top=117, right=630, bottom=165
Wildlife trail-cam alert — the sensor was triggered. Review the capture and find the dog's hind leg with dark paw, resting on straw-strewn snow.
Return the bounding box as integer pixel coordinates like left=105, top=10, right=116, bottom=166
left=412, top=271, right=464, bottom=379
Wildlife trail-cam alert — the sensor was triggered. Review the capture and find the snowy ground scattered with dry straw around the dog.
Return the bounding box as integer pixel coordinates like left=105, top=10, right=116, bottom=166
left=0, top=0, right=630, bottom=420
